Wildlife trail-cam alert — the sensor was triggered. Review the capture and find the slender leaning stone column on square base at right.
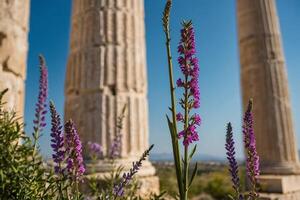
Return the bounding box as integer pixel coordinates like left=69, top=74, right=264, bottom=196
left=237, top=0, right=300, bottom=199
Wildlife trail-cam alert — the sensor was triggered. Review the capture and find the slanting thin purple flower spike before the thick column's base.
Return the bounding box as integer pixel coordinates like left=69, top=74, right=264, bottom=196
left=114, top=144, right=154, bottom=196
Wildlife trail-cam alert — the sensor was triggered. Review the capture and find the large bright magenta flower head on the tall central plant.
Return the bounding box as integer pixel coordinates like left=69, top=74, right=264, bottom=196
left=176, top=21, right=201, bottom=146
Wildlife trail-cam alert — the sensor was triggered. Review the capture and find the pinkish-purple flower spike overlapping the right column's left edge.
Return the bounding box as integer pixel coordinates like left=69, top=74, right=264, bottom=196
left=243, top=100, right=260, bottom=199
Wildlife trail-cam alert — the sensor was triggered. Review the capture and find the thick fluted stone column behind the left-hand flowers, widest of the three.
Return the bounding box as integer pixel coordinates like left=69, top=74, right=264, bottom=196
left=65, top=0, right=158, bottom=195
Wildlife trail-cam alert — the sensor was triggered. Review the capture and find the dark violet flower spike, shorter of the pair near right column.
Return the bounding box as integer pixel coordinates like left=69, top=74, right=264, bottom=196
left=225, top=123, right=242, bottom=199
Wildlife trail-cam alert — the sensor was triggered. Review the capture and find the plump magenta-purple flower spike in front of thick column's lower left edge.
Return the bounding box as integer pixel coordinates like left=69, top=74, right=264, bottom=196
left=65, top=120, right=85, bottom=181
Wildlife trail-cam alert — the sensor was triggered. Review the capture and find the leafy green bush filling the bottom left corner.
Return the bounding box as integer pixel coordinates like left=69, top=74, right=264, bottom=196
left=0, top=90, right=53, bottom=199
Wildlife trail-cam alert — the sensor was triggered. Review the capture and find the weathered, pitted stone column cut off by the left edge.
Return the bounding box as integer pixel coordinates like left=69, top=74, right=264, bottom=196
left=0, top=0, right=30, bottom=116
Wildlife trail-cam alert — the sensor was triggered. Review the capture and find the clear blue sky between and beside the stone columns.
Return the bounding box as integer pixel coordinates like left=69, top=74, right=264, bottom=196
left=25, top=0, right=300, bottom=157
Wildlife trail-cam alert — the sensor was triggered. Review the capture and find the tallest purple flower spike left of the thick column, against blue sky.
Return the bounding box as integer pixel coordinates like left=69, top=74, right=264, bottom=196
left=33, top=55, right=48, bottom=132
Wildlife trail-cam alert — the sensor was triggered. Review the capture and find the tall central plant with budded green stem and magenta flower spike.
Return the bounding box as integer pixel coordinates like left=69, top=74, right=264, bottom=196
left=162, top=0, right=201, bottom=200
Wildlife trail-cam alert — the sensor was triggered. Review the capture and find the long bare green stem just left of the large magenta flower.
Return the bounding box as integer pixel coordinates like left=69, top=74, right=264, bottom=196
left=165, top=27, right=183, bottom=199
